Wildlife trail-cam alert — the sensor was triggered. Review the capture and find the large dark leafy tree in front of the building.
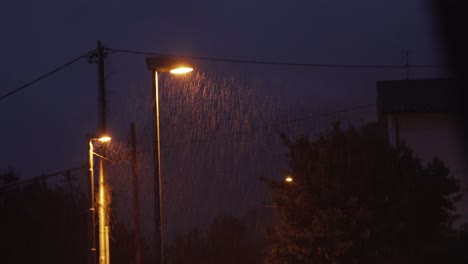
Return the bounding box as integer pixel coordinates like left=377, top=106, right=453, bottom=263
left=266, top=123, right=461, bottom=263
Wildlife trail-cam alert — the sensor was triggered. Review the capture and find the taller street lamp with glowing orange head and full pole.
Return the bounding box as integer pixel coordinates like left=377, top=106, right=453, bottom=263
left=146, top=56, right=193, bottom=264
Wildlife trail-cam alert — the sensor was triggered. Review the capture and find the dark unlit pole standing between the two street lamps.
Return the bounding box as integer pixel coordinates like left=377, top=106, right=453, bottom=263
left=130, top=123, right=142, bottom=264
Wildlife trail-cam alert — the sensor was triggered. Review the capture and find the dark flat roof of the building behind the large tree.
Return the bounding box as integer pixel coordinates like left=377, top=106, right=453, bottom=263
left=377, top=79, right=461, bottom=113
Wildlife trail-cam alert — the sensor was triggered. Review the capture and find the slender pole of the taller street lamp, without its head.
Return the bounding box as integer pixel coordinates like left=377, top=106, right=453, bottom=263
left=151, top=71, right=164, bottom=264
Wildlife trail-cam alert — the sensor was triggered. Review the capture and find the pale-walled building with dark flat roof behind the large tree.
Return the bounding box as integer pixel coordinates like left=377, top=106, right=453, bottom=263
left=377, top=79, right=468, bottom=225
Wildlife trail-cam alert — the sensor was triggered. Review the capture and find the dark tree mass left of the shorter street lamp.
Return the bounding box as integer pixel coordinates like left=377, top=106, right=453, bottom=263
left=0, top=170, right=88, bottom=263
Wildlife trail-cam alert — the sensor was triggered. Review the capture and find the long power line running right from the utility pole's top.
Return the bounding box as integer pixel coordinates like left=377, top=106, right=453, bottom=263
left=106, top=48, right=447, bottom=68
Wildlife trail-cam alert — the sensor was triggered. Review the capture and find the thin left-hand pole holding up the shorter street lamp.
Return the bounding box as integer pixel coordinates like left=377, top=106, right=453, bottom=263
left=88, top=140, right=96, bottom=264
